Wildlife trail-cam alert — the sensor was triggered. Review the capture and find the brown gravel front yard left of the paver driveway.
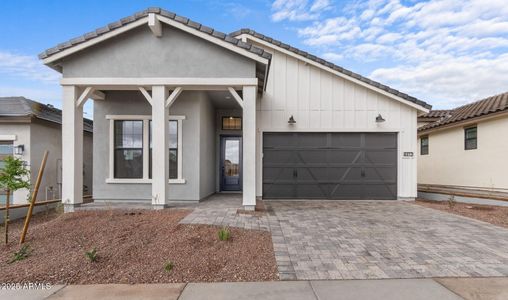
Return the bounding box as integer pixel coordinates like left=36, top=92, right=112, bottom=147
left=0, top=210, right=278, bottom=284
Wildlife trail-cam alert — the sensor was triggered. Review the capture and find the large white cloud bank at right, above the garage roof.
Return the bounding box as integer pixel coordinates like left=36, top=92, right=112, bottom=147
left=276, top=0, right=508, bottom=106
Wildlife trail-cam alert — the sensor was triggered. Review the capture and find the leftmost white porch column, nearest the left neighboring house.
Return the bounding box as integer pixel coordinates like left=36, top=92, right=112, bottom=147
left=62, top=86, right=83, bottom=212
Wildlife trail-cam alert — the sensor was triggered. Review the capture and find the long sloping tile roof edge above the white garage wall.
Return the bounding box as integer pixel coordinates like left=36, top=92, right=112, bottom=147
left=230, top=28, right=432, bottom=109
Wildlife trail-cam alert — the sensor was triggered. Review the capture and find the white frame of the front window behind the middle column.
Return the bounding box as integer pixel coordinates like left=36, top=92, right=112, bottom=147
left=106, top=115, right=186, bottom=184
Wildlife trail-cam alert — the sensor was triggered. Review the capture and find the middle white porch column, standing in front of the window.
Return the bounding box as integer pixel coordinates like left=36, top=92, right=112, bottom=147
left=152, top=85, right=169, bottom=209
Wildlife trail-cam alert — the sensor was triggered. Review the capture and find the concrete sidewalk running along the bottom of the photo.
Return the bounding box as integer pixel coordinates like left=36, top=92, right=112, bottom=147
left=0, top=278, right=508, bottom=300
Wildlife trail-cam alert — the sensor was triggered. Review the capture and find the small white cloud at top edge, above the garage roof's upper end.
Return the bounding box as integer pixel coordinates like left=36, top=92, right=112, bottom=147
left=272, top=0, right=331, bottom=22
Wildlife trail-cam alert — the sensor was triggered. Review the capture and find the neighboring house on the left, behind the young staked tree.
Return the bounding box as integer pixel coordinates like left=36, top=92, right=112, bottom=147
left=0, top=97, right=93, bottom=206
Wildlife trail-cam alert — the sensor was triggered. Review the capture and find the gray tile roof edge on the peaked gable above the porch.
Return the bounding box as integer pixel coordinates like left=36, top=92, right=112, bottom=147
left=39, top=7, right=272, bottom=61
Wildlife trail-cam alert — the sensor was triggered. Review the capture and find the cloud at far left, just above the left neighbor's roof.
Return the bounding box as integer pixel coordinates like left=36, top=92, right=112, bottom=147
left=0, top=50, right=60, bottom=82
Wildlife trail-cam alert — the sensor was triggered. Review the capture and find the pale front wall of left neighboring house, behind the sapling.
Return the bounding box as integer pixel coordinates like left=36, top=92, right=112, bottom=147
left=0, top=123, right=32, bottom=204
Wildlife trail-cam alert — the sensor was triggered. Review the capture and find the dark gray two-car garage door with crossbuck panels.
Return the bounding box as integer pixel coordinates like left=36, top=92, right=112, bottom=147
left=263, top=132, right=397, bottom=199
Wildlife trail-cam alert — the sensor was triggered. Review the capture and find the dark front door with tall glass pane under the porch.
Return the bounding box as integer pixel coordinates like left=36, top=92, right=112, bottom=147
left=221, top=136, right=242, bottom=191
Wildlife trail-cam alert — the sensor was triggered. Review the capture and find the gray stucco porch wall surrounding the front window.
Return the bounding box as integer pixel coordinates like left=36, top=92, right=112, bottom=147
left=93, top=91, right=215, bottom=201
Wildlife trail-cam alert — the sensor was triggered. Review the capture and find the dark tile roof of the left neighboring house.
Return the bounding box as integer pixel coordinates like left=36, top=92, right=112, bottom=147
left=0, top=97, right=93, bottom=132
